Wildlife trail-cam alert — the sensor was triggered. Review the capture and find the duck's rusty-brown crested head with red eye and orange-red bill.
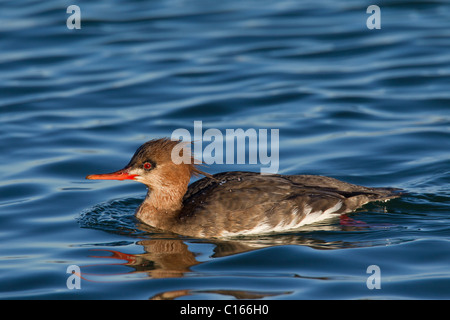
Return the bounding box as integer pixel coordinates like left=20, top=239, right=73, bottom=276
left=86, top=138, right=207, bottom=195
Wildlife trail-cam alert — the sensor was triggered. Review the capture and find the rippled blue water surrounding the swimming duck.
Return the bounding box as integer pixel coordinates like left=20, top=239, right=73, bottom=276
left=0, top=0, right=450, bottom=299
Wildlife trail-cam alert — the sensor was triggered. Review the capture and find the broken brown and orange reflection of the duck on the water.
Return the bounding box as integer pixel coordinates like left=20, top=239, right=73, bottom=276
left=76, top=212, right=376, bottom=299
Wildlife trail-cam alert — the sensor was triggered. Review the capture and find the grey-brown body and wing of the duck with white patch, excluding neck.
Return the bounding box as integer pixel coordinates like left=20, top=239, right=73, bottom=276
left=180, top=172, right=400, bottom=236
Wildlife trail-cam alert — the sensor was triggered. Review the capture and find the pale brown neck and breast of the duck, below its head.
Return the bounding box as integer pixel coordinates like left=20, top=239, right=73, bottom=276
left=136, top=184, right=187, bottom=230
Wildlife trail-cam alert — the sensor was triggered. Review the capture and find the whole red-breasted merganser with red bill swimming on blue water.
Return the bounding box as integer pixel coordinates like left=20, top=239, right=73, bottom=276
left=86, top=138, right=400, bottom=238
